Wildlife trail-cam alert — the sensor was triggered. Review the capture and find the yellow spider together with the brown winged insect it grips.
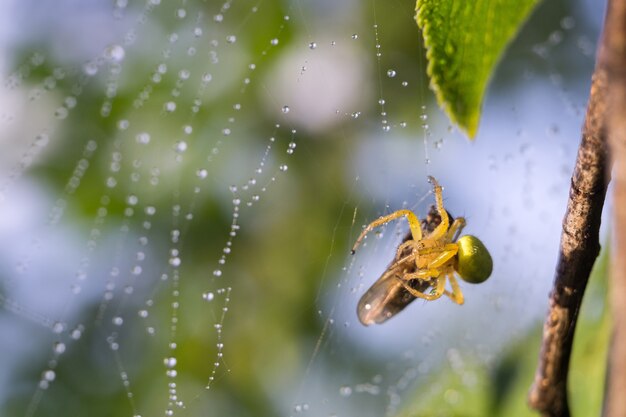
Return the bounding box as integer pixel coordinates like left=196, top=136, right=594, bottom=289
left=352, top=176, right=493, bottom=326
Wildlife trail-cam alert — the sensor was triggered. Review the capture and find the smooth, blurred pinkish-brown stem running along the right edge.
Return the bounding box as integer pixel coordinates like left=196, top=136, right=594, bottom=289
left=598, top=0, right=626, bottom=417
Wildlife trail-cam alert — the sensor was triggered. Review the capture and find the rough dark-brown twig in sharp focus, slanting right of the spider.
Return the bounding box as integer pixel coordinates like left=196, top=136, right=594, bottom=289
left=528, top=9, right=608, bottom=417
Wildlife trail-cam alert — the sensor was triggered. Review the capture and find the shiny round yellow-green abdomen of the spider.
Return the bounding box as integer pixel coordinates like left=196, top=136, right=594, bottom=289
left=456, top=235, right=493, bottom=284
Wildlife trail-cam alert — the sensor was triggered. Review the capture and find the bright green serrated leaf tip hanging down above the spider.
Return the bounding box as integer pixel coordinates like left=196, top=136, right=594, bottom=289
left=415, top=0, right=539, bottom=138
